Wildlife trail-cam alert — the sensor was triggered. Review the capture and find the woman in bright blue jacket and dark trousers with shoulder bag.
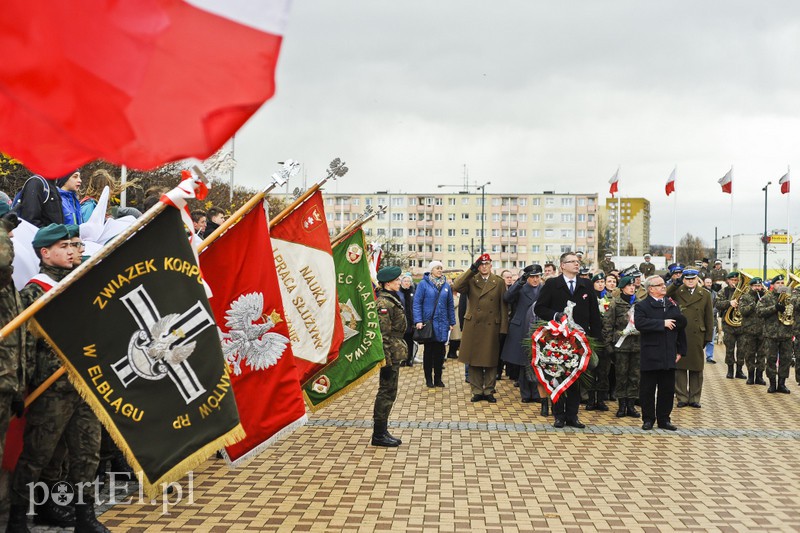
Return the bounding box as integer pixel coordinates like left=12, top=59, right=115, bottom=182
left=413, top=261, right=456, bottom=387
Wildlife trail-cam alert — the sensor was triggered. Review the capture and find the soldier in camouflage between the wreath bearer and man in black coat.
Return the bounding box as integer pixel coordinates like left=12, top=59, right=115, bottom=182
left=603, top=276, right=641, bottom=418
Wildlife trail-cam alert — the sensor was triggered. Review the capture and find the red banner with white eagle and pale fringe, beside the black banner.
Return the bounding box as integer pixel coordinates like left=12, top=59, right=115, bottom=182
left=200, top=200, right=306, bottom=465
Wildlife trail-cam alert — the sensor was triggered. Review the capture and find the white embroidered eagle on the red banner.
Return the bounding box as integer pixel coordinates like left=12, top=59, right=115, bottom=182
left=220, top=292, right=289, bottom=376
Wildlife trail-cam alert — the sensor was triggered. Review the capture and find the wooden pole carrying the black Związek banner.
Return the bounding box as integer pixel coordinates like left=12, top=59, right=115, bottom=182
left=0, top=166, right=208, bottom=339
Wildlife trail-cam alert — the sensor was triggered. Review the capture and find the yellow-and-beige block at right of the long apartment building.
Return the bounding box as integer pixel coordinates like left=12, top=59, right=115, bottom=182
left=600, top=198, right=650, bottom=256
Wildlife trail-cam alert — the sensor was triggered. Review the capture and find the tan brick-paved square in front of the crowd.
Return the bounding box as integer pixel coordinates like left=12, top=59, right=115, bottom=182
left=101, top=346, right=800, bottom=532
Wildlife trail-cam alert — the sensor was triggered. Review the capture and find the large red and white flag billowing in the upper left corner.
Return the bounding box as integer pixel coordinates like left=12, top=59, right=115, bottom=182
left=0, top=0, right=289, bottom=176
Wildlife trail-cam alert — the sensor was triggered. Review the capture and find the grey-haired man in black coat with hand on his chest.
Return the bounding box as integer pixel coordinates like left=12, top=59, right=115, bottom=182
left=633, top=276, right=687, bottom=431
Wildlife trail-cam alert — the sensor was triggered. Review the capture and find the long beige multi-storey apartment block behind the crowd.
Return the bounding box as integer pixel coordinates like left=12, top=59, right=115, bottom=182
left=324, top=191, right=598, bottom=273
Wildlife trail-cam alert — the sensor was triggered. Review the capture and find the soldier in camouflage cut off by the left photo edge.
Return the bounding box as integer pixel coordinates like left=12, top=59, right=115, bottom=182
left=0, top=220, right=25, bottom=470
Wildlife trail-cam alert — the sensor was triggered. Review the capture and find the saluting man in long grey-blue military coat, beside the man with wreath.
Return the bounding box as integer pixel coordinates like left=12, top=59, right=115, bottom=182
left=500, top=265, right=542, bottom=403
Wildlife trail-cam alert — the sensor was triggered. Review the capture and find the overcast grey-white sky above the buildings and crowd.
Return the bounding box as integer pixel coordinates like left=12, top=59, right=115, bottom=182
left=223, top=0, right=800, bottom=246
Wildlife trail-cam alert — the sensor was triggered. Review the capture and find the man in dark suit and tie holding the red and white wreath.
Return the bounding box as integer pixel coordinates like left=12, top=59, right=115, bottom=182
left=533, top=252, right=603, bottom=428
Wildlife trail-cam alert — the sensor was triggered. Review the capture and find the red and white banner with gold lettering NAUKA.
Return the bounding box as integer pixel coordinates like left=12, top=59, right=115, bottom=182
left=272, top=191, right=344, bottom=385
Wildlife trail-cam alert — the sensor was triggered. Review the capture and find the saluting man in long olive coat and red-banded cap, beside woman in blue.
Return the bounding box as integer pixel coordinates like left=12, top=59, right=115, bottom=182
left=453, top=254, right=508, bottom=403
